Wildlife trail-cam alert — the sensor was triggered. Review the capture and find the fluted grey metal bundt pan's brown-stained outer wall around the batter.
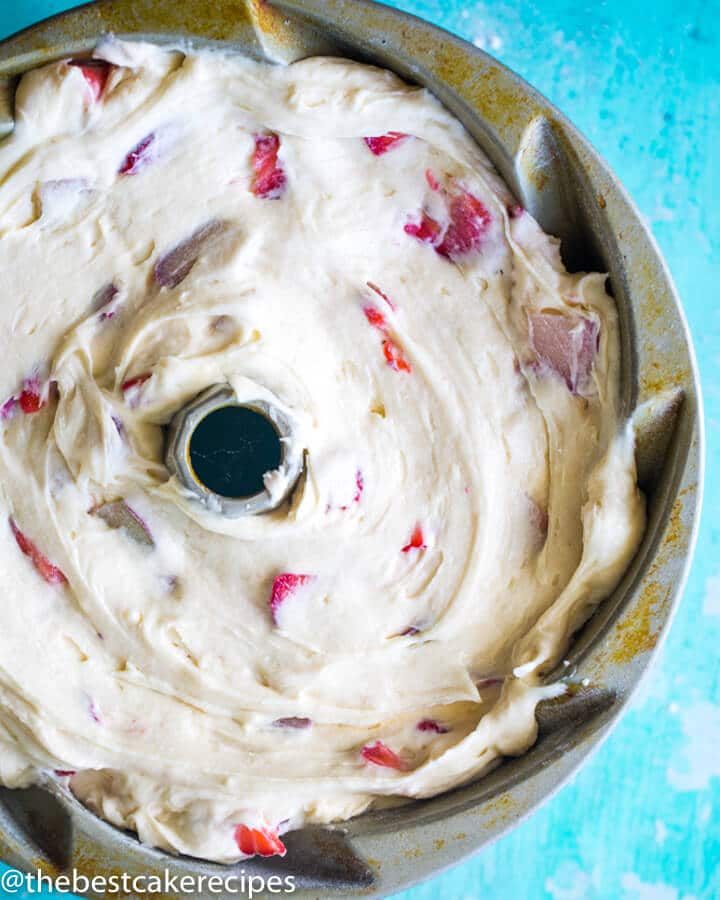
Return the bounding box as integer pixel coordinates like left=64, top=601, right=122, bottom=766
left=0, top=0, right=703, bottom=898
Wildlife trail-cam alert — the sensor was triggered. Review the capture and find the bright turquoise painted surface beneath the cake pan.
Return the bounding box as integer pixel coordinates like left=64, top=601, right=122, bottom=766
left=0, top=0, right=720, bottom=900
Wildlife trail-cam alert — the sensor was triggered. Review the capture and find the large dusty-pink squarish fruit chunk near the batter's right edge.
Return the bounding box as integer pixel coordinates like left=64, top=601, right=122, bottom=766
left=529, top=312, right=600, bottom=394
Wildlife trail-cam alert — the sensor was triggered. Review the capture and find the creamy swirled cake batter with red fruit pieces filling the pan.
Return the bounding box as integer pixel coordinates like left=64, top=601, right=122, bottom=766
left=0, top=40, right=644, bottom=861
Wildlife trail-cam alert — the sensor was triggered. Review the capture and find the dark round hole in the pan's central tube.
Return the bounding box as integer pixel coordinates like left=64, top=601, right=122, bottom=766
left=189, top=406, right=282, bottom=499
